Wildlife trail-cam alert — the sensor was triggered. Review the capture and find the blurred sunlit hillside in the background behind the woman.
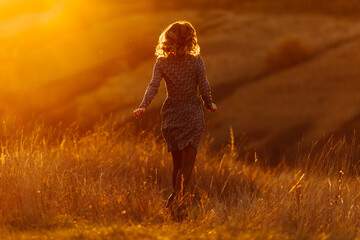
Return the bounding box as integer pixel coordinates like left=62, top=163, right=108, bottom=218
left=0, top=1, right=360, bottom=160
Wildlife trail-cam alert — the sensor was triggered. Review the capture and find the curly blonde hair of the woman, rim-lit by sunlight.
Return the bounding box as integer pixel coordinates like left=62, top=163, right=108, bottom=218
left=155, top=21, right=200, bottom=58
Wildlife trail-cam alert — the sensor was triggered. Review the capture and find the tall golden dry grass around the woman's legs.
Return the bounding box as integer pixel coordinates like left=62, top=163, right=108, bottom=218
left=0, top=121, right=360, bottom=239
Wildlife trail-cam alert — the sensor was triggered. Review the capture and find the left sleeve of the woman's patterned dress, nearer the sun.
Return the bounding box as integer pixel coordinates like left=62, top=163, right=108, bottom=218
left=139, top=59, right=162, bottom=108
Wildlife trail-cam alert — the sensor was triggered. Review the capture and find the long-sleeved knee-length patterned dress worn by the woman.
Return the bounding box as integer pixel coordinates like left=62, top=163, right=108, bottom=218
left=139, top=55, right=212, bottom=152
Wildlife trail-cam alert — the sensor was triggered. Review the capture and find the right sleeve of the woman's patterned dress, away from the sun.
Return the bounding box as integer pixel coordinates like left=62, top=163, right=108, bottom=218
left=197, top=55, right=212, bottom=109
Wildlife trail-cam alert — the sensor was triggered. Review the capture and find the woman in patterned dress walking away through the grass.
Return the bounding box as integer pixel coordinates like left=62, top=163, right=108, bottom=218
left=134, top=21, right=217, bottom=219
